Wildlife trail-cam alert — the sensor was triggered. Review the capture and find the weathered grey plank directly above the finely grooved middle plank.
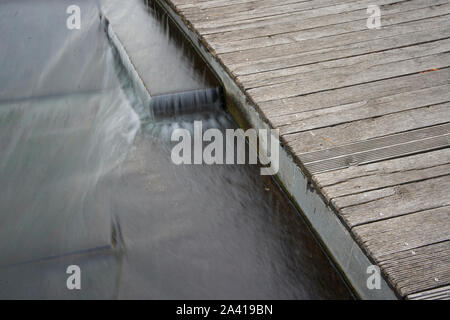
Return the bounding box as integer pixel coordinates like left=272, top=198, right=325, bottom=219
left=282, top=103, right=450, bottom=155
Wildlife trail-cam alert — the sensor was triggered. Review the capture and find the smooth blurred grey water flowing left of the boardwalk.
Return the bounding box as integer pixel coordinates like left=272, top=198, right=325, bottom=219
left=0, top=0, right=350, bottom=299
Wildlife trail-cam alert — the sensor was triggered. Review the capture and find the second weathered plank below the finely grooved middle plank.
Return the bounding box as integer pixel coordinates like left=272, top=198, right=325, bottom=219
left=332, top=175, right=450, bottom=227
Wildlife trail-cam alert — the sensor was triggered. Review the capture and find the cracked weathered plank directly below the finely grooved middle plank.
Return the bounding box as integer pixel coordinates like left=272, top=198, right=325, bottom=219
left=313, top=148, right=450, bottom=200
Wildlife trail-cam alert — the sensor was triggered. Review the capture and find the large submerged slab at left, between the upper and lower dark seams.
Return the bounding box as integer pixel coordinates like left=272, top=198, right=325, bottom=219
left=0, top=91, right=137, bottom=266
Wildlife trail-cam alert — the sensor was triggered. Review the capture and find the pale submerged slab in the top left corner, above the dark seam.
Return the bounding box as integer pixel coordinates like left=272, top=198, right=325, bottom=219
left=0, top=0, right=113, bottom=101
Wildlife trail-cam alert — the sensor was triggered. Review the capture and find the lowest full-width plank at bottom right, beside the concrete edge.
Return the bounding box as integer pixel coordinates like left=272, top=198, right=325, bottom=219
left=378, top=241, right=450, bottom=297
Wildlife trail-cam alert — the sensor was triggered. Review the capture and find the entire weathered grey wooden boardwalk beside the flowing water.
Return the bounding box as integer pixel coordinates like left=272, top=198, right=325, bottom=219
left=161, top=0, right=450, bottom=299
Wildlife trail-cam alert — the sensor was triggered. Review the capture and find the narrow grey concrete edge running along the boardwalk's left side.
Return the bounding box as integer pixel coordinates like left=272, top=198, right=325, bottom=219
left=155, top=0, right=398, bottom=300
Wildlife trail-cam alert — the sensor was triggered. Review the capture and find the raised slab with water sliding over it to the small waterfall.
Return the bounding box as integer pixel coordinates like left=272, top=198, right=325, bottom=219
left=101, top=0, right=218, bottom=96
